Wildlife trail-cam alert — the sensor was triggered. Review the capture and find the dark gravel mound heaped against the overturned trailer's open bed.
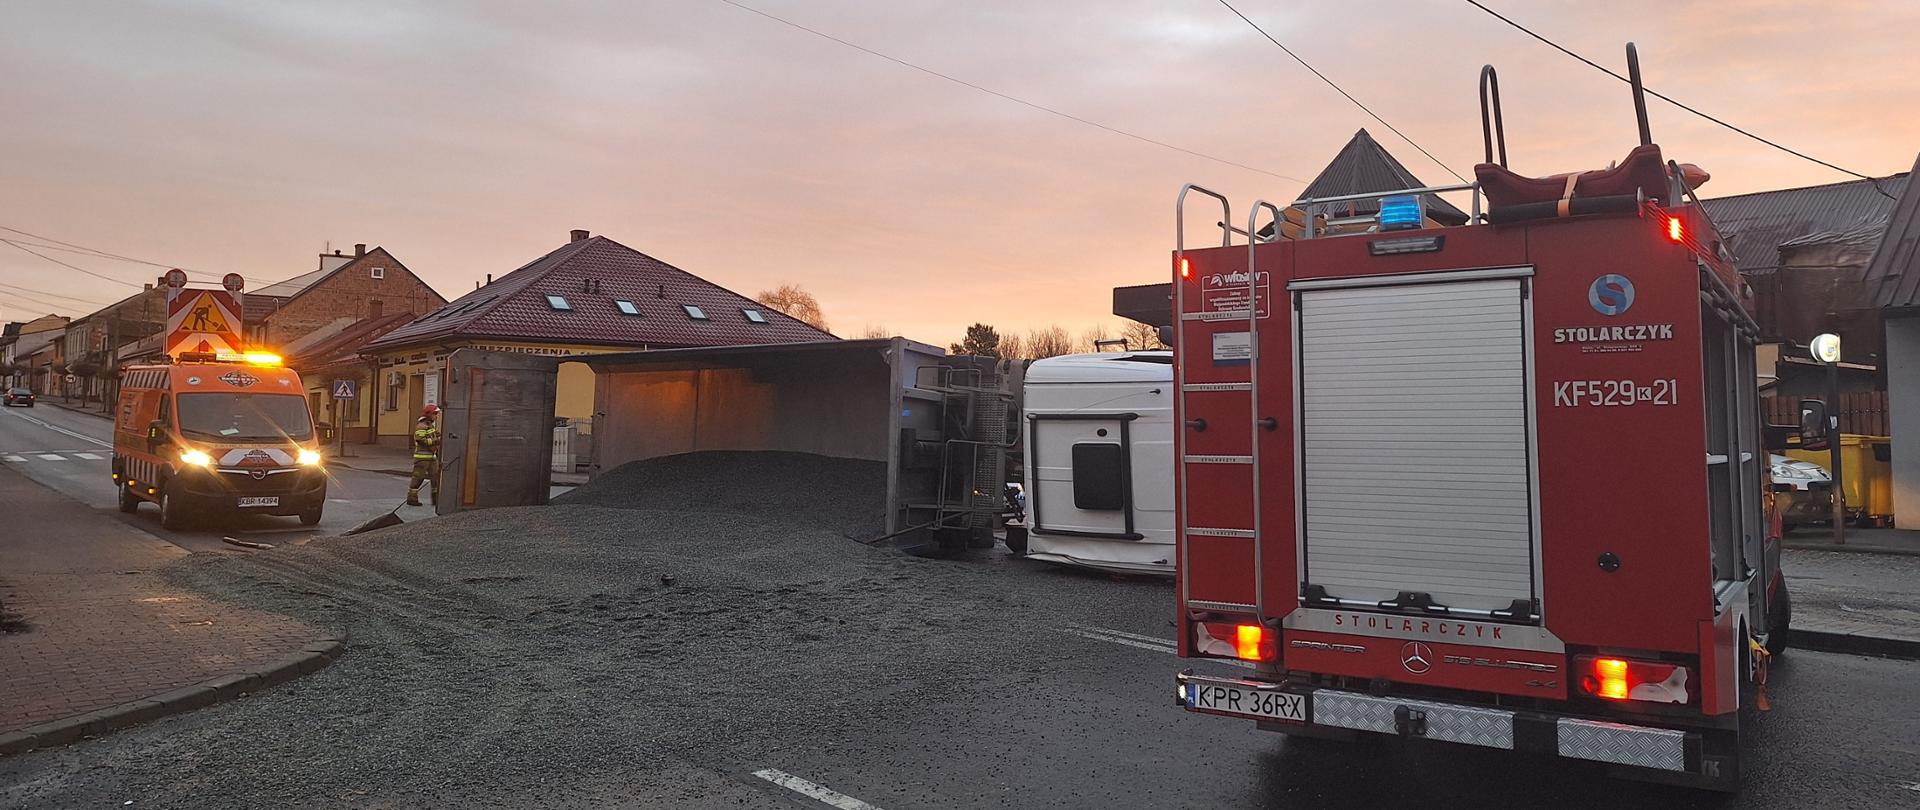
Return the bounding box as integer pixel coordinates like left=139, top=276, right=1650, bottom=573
left=553, top=451, right=887, bottom=539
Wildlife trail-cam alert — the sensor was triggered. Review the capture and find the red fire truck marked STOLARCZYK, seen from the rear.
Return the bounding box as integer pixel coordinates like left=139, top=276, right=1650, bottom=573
left=1173, top=46, right=1797, bottom=789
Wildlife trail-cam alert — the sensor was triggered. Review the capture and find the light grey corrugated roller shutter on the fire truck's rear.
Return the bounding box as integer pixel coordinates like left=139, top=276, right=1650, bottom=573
left=1300, top=278, right=1534, bottom=610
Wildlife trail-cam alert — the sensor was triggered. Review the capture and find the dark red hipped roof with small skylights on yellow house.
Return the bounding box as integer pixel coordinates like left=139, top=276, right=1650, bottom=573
left=369, top=236, right=835, bottom=349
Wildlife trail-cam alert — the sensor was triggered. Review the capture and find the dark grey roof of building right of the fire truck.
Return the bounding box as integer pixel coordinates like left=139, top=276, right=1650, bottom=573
left=1701, top=173, right=1908, bottom=276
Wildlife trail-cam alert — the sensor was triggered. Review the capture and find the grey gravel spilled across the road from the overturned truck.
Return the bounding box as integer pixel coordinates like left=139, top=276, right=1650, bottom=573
left=0, top=452, right=1152, bottom=808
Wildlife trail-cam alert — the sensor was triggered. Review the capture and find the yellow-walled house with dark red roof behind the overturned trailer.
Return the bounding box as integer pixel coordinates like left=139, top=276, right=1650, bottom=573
left=361, top=230, right=835, bottom=443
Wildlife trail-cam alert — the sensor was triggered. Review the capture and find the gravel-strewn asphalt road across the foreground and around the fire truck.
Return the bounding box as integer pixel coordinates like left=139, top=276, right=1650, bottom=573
left=0, top=495, right=1920, bottom=810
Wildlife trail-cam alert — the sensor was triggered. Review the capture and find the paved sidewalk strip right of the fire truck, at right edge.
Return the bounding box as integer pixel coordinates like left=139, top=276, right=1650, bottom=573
left=1782, top=549, right=1920, bottom=656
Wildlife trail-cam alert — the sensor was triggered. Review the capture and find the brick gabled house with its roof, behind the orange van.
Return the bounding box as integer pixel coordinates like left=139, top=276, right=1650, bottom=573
left=244, top=244, right=447, bottom=351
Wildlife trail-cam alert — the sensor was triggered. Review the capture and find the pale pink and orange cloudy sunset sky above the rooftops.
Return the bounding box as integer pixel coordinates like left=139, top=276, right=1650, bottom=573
left=0, top=0, right=1920, bottom=345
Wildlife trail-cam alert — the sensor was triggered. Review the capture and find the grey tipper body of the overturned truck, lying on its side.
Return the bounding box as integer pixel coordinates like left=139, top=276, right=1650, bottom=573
left=440, top=338, right=1020, bottom=547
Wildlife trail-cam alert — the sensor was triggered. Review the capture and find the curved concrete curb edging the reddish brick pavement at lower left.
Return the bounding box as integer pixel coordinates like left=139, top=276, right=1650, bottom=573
left=0, top=637, right=346, bottom=756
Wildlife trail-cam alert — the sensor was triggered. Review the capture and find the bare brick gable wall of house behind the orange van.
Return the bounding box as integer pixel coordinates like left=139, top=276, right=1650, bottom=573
left=248, top=248, right=447, bottom=351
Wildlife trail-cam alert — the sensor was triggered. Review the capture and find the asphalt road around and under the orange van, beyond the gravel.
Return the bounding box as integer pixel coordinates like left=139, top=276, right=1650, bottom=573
left=0, top=403, right=430, bottom=551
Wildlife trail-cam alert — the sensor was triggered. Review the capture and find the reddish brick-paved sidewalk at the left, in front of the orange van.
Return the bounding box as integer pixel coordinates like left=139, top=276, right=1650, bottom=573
left=0, top=470, right=324, bottom=733
